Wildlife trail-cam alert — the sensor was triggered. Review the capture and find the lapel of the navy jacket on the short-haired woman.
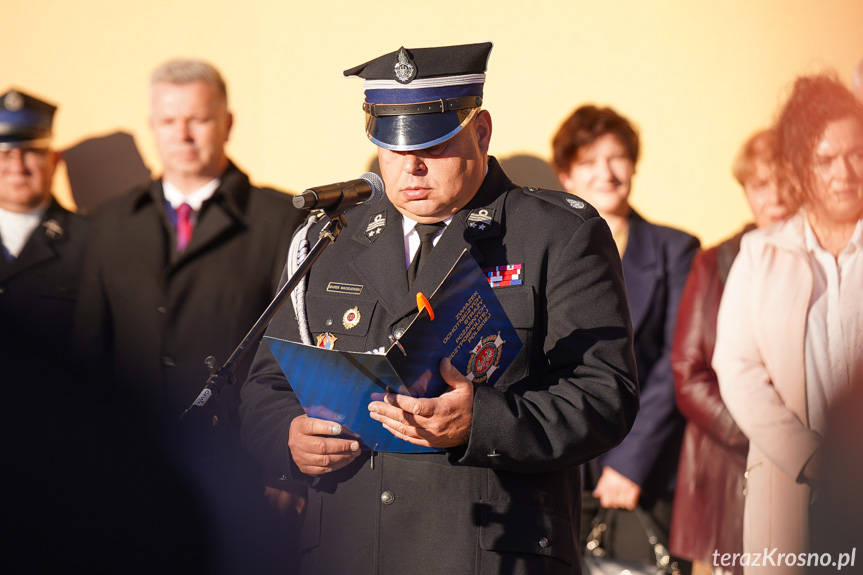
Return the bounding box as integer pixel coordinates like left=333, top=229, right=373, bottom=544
left=623, top=210, right=659, bottom=332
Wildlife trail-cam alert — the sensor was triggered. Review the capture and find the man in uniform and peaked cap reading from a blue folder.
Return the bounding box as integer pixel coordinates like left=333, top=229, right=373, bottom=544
left=241, top=43, right=638, bottom=575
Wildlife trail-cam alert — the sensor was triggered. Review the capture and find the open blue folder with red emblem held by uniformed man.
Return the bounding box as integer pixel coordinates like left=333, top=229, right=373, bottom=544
left=264, top=250, right=523, bottom=453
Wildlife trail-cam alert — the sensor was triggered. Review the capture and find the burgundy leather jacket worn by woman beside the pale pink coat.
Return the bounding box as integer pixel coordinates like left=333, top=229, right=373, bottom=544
left=670, top=226, right=754, bottom=572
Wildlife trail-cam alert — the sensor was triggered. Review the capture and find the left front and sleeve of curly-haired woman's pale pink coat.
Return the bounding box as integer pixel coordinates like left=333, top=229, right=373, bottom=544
left=713, top=212, right=821, bottom=572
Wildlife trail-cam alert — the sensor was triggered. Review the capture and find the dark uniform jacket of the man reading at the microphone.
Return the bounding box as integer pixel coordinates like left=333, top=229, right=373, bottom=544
left=241, top=158, right=637, bottom=575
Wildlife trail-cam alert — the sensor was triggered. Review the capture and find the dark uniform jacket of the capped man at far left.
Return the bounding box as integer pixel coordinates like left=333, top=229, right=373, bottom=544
left=0, top=200, right=89, bottom=359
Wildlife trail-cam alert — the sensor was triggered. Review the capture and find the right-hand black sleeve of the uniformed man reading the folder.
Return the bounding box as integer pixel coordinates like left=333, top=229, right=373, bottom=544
left=458, top=217, right=638, bottom=473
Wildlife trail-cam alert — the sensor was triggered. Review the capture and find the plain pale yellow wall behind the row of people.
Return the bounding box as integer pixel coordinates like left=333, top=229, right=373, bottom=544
left=0, top=0, right=863, bottom=244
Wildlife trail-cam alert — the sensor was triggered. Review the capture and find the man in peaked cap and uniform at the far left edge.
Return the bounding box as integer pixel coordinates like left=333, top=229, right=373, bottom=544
left=0, top=89, right=87, bottom=354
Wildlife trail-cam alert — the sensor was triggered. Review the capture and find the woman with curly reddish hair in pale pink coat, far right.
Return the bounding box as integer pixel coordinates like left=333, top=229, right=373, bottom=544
left=713, top=76, right=863, bottom=573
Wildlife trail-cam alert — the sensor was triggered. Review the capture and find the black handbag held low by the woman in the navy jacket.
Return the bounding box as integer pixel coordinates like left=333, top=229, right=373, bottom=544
left=582, top=506, right=680, bottom=575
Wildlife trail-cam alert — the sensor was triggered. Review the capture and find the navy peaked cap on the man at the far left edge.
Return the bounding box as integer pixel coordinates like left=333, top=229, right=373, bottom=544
left=0, top=89, right=57, bottom=150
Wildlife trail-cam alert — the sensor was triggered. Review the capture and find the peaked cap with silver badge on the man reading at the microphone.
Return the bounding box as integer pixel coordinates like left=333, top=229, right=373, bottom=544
left=344, top=42, right=492, bottom=151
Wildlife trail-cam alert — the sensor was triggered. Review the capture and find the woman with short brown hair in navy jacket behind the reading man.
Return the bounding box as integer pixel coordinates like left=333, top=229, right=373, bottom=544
left=553, top=105, right=699, bottom=562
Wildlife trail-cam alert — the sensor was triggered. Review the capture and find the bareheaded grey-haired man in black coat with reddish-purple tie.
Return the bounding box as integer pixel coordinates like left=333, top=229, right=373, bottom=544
left=76, top=60, right=301, bottom=572
